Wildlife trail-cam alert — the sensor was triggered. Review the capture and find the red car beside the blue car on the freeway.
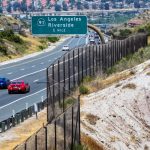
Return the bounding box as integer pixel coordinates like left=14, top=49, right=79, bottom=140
left=8, top=81, right=30, bottom=94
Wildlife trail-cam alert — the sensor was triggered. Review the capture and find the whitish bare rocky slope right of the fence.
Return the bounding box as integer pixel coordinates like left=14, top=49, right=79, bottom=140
left=81, top=60, right=150, bottom=150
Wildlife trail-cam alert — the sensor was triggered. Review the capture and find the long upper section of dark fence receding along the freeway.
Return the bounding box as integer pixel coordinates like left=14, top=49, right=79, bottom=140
left=47, top=34, right=147, bottom=122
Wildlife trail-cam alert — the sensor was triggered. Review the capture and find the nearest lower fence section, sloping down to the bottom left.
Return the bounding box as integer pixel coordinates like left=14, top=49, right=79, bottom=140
left=14, top=98, right=80, bottom=150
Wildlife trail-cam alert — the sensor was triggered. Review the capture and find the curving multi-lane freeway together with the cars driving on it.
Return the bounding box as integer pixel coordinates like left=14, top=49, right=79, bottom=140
left=0, top=32, right=105, bottom=121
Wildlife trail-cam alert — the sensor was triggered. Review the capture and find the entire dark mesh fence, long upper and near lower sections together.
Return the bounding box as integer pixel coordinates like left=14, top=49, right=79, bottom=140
left=15, top=34, right=147, bottom=150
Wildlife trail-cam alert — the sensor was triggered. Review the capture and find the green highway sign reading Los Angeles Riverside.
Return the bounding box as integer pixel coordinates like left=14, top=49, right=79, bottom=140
left=32, top=16, right=87, bottom=36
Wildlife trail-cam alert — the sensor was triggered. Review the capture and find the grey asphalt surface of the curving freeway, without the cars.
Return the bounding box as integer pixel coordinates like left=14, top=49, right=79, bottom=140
left=0, top=36, right=87, bottom=121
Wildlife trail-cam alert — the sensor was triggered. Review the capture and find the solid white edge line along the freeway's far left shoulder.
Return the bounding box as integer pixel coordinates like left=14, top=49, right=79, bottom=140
left=0, top=39, right=72, bottom=70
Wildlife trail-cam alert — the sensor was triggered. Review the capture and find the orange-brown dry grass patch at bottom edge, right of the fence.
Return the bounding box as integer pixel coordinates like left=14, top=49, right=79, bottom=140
left=81, top=133, right=104, bottom=150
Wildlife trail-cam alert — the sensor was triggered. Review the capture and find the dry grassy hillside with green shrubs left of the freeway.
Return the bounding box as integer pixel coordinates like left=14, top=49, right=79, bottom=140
left=0, top=16, right=59, bottom=62
